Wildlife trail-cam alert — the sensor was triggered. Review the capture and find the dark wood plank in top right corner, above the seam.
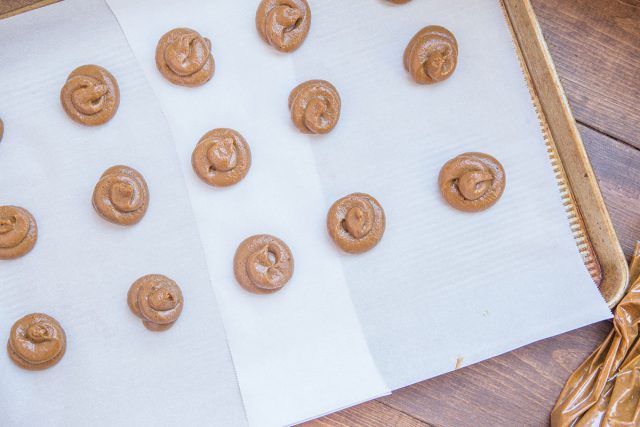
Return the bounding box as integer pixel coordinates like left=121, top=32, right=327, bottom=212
left=532, top=0, right=640, bottom=148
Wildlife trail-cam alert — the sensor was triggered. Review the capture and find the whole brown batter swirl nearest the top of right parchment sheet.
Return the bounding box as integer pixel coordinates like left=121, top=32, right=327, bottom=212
left=404, top=25, right=458, bottom=84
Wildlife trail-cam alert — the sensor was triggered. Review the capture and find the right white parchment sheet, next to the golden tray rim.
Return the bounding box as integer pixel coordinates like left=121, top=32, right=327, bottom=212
left=292, top=0, right=611, bottom=389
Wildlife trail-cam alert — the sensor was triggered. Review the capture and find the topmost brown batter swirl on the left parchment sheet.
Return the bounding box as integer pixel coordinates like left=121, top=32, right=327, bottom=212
left=60, top=65, right=120, bottom=126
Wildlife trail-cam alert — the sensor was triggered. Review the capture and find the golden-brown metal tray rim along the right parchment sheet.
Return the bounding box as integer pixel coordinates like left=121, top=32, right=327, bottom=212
left=499, top=0, right=629, bottom=309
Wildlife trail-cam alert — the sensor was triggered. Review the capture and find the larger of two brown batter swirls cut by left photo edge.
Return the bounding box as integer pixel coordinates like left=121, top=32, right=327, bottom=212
left=0, top=206, right=38, bottom=259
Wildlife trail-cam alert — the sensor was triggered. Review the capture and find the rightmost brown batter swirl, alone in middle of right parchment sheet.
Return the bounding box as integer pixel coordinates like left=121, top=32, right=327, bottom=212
left=438, top=153, right=506, bottom=212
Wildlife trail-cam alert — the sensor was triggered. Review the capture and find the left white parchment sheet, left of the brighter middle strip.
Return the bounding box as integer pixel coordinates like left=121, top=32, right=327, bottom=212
left=0, top=0, right=246, bottom=427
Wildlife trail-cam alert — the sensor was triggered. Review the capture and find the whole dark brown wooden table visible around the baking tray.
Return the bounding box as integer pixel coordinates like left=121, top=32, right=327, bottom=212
left=0, top=0, right=640, bottom=427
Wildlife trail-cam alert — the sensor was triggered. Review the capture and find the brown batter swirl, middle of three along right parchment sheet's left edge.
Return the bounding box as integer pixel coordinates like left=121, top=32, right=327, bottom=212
left=289, top=80, right=341, bottom=134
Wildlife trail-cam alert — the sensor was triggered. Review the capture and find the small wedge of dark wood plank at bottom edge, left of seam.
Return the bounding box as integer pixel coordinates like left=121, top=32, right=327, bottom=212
left=303, top=401, right=430, bottom=427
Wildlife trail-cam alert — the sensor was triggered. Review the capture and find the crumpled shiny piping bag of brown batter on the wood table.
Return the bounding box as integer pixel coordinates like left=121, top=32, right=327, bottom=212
left=551, top=242, right=640, bottom=427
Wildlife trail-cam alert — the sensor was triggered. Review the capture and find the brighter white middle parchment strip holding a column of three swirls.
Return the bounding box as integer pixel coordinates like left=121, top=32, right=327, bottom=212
left=109, top=0, right=388, bottom=426
